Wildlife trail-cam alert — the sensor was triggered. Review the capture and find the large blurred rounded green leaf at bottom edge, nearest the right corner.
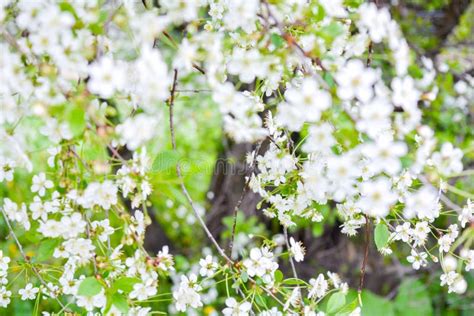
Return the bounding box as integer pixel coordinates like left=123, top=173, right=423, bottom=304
left=395, top=278, right=433, bottom=316
